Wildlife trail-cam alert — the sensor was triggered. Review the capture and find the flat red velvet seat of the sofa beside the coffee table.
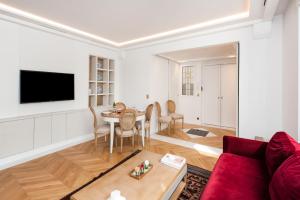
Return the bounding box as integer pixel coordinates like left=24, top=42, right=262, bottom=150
left=200, top=153, right=269, bottom=200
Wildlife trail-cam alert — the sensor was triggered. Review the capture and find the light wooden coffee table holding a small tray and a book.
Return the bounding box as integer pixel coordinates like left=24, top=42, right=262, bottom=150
left=71, top=151, right=187, bottom=200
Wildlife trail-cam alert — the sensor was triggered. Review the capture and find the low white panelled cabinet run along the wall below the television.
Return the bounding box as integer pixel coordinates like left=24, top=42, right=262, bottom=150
left=0, top=109, right=93, bottom=169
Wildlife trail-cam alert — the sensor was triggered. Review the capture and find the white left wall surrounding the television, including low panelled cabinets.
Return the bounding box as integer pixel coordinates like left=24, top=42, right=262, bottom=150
left=0, top=20, right=120, bottom=163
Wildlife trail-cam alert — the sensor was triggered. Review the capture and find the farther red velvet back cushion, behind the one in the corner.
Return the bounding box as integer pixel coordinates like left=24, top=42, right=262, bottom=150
left=266, top=132, right=299, bottom=176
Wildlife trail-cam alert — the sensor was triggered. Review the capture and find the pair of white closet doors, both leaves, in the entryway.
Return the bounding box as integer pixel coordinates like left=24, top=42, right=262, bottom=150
left=202, top=64, right=237, bottom=128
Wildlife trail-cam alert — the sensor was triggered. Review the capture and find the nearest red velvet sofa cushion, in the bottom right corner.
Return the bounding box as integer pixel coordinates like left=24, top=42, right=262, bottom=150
left=269, top=152, right=300, bottom=200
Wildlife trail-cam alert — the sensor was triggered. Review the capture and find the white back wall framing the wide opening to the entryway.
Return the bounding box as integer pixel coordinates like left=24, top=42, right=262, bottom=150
left=121, top=16, right=282, bottom=141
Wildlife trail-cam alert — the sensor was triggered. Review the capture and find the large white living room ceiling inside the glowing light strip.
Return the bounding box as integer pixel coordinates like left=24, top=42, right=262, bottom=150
left=0, top=0, right=250, bottom=43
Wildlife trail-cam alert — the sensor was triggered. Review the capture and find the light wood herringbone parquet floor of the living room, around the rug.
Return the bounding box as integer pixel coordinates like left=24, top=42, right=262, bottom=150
left=0, top=135, right=217, bottom=200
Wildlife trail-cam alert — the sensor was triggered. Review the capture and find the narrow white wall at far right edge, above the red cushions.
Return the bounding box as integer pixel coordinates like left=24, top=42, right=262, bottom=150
left=282, top=0, right=299, bottom=139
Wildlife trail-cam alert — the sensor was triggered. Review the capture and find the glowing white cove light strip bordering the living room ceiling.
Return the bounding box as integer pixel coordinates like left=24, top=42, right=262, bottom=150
left=0, top=3, right=249, bottom=47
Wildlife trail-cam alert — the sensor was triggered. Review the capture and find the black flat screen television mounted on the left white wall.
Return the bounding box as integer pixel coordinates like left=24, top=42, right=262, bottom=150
left=20, top=70, right=74, bottom=104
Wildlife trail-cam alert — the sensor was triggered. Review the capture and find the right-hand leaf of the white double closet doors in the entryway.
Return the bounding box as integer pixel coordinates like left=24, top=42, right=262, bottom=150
left=220, top=64, right=237, bottom=128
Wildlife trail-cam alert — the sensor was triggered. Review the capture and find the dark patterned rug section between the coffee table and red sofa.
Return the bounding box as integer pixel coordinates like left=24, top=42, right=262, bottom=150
left=178, top=164, right=211, bottom=200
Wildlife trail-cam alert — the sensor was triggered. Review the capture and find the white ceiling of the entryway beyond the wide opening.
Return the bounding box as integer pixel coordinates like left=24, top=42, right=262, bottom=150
left=159, top=43, right=236, bottom=62
